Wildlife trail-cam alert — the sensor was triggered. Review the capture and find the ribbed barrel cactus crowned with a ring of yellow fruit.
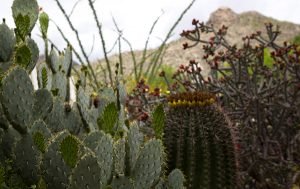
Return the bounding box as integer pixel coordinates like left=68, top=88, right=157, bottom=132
left=164, top=92, right=237, bottom=189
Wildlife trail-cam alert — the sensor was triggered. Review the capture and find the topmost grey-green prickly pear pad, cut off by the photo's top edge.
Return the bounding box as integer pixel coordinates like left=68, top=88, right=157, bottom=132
left=11, top=0, right=39, bottom=32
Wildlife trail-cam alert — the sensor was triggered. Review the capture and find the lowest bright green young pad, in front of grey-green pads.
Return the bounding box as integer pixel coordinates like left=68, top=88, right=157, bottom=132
left=59, top=136, right=79, bottom=167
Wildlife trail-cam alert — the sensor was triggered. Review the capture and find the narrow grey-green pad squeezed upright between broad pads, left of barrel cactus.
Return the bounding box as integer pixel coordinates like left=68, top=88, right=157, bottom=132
left=114, top=138, right=126, bottom=175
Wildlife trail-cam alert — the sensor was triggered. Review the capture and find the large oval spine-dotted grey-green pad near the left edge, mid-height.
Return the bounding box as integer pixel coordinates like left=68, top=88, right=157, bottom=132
left=1, top=67, right=34, bottom=133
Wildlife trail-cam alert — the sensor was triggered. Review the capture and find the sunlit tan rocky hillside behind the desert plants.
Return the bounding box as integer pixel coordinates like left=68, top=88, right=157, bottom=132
left=94, top=8, right=300, bottom=78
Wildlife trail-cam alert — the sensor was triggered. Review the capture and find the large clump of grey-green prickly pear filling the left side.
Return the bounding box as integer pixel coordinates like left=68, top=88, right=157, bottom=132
left=0, top=0, right=184, bottom=189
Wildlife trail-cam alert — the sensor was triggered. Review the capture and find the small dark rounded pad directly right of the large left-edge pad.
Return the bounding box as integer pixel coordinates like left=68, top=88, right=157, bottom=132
left=33, top=89, right=53, bottom=120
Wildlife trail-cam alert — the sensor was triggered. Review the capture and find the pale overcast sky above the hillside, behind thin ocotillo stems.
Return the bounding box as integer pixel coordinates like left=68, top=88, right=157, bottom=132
left=0, top=0, right=300, bottom=60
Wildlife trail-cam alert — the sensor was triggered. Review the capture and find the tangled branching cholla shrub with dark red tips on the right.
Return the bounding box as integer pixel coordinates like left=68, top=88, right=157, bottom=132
left=174, top=20, right=300, bottom=189
